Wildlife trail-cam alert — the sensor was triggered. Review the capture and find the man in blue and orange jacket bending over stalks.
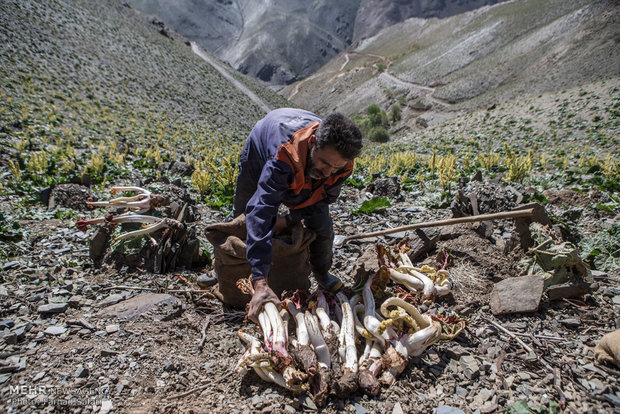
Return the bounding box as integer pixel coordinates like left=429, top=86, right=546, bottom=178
left=232, top=108, right=362, bottom=320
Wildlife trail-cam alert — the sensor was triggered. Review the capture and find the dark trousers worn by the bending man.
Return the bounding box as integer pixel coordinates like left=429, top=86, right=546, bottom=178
left=229, top=149, right=334, bottom=275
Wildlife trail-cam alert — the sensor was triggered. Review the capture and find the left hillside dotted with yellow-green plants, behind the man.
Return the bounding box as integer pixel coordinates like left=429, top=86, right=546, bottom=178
left=0, top=0, right=286, bottom=199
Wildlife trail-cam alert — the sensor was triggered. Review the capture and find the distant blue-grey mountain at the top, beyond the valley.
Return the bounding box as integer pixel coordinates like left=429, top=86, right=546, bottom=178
left=120, top=0, right=508, bottom=85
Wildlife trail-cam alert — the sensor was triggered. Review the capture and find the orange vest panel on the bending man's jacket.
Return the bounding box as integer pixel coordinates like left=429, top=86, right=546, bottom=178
left=276, top=122, right=353, bottom=210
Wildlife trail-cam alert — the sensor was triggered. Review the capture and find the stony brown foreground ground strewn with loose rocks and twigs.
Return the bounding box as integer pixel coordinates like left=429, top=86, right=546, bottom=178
left=0, top=172, right=620, bottom=414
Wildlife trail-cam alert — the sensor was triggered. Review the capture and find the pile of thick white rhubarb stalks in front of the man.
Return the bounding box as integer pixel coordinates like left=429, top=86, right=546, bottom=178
left=236, top=240, right=465, bottom=407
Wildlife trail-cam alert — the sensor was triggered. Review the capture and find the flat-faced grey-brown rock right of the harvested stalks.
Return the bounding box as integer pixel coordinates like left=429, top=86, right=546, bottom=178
left=490, top=275, right=544, bottom=315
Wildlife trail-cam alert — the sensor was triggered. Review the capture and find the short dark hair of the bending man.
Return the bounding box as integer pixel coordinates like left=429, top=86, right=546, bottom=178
left=315, top=113, right=362, bottom=160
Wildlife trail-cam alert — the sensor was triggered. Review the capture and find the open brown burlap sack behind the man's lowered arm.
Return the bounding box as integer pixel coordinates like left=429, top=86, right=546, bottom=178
left=205, top=215, right=316, bottom=308
